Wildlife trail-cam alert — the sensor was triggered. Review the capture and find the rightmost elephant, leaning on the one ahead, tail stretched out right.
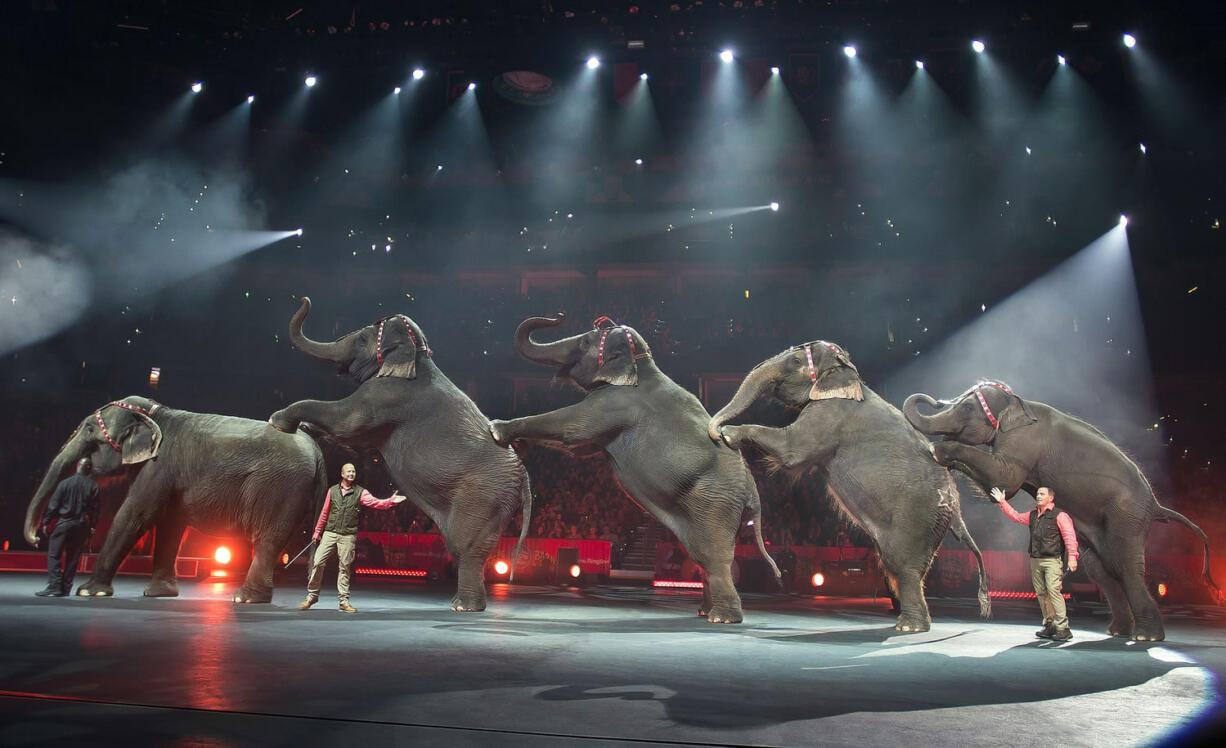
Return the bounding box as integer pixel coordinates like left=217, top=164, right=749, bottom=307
left=902, top=380, right=1217, bottom=641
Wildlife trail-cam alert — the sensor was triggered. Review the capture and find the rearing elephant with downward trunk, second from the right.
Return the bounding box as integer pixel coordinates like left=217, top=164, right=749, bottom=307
left=707, top=340, right=992, bottom=632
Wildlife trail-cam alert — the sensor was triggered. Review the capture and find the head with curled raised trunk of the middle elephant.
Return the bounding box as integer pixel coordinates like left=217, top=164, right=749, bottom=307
left=515, top=313, right=651, bottom=391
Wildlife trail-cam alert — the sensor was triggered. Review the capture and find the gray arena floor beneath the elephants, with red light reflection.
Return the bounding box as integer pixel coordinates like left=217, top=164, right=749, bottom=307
left=0, top=573, right=1226, bottom=748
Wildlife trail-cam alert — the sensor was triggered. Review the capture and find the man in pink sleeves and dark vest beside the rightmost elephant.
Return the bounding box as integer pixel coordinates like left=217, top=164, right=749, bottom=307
left=992, top=486, right=1078, bottom=641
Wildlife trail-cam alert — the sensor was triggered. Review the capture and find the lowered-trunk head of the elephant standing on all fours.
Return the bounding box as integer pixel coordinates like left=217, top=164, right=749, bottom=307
left=25, top=396, right=162, bottom=546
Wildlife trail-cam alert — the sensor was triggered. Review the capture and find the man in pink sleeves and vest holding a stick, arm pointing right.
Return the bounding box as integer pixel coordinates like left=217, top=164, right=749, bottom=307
left=298, top=462, right=405, bottom=613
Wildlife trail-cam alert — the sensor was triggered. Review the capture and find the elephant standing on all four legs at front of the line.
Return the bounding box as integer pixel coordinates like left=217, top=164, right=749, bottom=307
left=26, top=395, right=327, bottom=603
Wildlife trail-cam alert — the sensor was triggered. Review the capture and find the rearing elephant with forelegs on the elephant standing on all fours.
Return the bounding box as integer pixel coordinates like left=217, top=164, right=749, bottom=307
left=268, top=297, right=532, bottom=612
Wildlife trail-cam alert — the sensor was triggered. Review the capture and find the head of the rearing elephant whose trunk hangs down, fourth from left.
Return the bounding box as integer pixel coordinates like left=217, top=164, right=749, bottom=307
left=707, top=340, right=864, bottom=440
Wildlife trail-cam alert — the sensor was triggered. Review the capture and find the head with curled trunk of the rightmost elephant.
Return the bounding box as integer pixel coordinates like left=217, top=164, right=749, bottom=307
left=902, top=380, right=1036, bottom=444
